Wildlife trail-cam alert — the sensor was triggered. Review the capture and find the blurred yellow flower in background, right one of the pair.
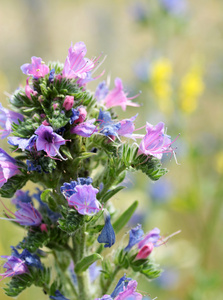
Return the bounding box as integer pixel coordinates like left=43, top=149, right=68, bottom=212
left=180, top=65, right=204, bottom=114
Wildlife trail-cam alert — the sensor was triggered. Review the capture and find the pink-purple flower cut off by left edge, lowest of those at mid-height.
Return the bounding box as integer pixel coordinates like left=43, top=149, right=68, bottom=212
left=0, top=148, right=20, bottom=188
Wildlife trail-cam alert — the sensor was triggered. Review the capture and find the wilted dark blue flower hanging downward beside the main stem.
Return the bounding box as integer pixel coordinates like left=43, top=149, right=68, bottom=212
left=97, top=210, right=115, bottom=248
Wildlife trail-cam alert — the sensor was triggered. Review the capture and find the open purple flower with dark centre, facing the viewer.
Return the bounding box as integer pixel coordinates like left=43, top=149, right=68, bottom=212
left=35, top=125, right=66, bottom=159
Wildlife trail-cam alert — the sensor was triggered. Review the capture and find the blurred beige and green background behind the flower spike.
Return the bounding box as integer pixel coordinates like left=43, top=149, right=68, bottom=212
left=0, top=0, right=223, bottom=300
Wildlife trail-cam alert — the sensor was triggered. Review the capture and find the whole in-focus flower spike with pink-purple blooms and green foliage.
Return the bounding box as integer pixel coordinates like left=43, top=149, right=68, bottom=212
left=0, top=42, right=179, bottom=300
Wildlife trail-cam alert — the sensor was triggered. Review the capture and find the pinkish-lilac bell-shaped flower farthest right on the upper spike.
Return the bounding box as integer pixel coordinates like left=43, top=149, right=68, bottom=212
left=138, top=122, right=173, bottom=159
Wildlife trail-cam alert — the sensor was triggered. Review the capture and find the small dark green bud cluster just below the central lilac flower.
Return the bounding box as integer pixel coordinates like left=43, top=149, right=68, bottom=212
left=58, top=206, right=84, bottom=234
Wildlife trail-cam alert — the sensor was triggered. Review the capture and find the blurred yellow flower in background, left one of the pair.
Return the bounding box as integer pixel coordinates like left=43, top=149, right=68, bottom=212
left=150, top=58, right=173, bottom=114
